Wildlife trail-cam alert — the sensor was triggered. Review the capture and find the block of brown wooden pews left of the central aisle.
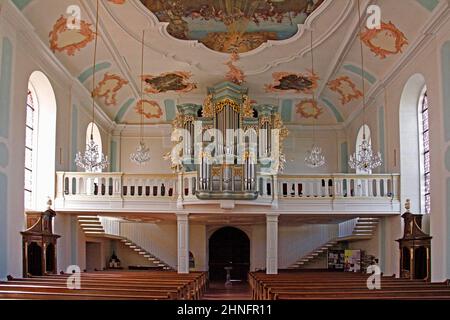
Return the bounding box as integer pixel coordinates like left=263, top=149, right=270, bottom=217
left=0, top=271, right=207, bottom=300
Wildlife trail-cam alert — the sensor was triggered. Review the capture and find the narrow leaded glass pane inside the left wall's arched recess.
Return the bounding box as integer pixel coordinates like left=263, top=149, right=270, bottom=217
left=24, top=84, right=38, bottom=209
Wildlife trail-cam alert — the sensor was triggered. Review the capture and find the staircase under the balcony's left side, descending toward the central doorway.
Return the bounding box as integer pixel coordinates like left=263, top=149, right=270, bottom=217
left=78, top=215, right=173, bottom=270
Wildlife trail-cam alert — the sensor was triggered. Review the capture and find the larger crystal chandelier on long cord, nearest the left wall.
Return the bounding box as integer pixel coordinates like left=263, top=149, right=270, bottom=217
left=75, top=0, right=109, bottom=172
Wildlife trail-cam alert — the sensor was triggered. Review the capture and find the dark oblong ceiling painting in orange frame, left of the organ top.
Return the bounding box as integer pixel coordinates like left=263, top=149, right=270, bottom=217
left=142, top=71, right=197, bottom=93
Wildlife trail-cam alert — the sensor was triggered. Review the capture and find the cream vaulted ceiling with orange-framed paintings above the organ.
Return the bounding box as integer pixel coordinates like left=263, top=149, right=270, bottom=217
left=13, top=0, right=442, bottom=125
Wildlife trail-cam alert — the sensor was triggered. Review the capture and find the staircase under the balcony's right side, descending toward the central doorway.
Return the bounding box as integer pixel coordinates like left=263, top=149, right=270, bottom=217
left=289, top=218, right=379, bottom=269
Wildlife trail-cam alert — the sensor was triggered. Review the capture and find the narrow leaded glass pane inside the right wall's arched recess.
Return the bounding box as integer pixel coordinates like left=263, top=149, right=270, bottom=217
left=417, top=87, right=431, bottom=213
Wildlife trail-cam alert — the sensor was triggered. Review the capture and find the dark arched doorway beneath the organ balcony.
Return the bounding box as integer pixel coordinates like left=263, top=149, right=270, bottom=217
left=209, top=227, right=250, bottom=281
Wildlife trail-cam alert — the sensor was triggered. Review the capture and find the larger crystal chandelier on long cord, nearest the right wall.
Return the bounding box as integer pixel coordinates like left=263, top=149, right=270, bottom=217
left=348, top=0, right=383, bottom=172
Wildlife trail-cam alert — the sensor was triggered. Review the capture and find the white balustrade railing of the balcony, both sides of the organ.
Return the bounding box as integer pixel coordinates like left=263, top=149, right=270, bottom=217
left=56, top=172, right=400, bottom=210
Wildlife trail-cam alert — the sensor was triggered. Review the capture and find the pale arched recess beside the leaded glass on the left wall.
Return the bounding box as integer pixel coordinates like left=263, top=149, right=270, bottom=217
left=24, top=71, right=57, bottom=210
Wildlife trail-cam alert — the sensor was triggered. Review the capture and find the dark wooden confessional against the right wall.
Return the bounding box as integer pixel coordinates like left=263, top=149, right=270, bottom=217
left=397, top=200, right=432, bottom=281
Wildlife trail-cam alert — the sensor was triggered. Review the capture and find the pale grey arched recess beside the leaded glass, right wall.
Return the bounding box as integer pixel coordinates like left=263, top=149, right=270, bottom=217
left=399, top=73, right=426, bottom=212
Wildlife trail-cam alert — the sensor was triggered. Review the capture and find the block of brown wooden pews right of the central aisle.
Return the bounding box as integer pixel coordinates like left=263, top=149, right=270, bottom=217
left=249, top=272, right=450, bottom=300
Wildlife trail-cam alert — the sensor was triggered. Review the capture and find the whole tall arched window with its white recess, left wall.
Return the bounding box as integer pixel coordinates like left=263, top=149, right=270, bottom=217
left=24, top=71, right=56, bottom=211
